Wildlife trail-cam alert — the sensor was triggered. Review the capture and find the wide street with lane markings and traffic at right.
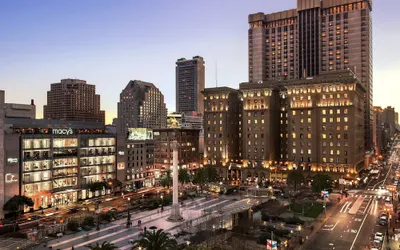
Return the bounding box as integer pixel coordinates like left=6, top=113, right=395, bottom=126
left=306, top=144, right=398, bottom=250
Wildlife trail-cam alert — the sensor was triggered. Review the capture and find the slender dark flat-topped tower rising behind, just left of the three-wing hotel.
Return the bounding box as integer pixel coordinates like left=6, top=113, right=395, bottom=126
left=176, top=56, right=205, bottom=114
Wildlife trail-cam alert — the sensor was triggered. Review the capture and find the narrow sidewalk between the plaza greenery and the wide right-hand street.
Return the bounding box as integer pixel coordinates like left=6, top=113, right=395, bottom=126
left=295, top=194, right=347, bottom=250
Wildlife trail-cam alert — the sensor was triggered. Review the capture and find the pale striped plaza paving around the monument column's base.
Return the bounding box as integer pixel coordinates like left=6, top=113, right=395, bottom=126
left=43, top=198, right=235, bottom=250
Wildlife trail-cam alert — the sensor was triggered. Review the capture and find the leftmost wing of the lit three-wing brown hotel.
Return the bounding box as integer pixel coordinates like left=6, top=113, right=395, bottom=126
left=203, top=87, right=242, bottom=180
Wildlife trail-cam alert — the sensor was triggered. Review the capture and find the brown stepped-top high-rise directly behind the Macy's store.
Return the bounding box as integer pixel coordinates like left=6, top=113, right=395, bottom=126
left=43, top=79, right=105, bottom=124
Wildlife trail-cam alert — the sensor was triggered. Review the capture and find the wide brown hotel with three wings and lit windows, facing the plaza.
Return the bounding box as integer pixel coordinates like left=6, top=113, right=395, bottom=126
left=203, top=70, right=366, bottom=181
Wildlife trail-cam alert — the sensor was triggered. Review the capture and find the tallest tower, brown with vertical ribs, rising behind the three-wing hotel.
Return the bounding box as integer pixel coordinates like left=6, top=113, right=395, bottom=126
left=248, top=0, right=373, bottom=150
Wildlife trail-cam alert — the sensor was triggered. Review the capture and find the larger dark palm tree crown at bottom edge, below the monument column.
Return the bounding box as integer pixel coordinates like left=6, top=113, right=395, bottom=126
left=131, top=229, right=177, bottom=250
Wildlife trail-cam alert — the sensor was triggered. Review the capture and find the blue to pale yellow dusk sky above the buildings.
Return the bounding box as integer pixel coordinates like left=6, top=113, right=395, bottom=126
left=0, top=0, right=400, bottom=123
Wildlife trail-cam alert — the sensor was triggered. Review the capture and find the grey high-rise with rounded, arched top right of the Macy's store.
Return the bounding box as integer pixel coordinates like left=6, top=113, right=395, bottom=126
left=117, top=80, right=167, bottom=135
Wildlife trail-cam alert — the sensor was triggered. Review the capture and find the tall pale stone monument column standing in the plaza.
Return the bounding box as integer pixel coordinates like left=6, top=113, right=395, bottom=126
left=167, top=141, right=183, bottom=221
